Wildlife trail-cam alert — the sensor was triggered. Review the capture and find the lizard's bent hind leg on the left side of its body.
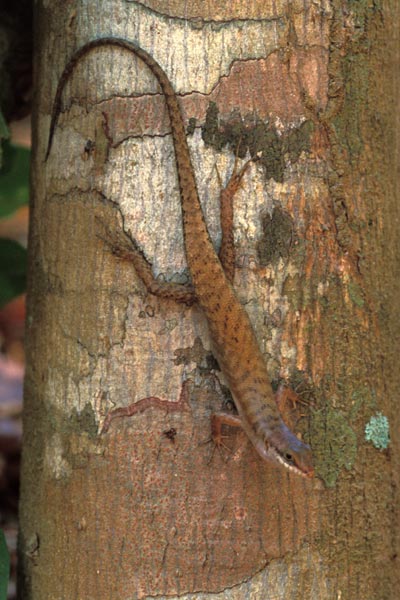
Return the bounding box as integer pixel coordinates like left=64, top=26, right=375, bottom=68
left=96, top=217, right=196, bottom=306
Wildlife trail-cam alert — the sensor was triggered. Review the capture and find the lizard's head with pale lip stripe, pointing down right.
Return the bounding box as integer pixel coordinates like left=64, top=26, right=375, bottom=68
left=257, top=422, right=314, bottom=478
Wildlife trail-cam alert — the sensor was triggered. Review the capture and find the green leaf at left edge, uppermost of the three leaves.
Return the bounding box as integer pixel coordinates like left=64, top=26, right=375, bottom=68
left=0, top=142, right=31, bottom=218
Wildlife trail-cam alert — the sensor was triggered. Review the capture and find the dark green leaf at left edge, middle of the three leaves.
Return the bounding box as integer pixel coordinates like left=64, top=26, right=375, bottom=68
left=0, top=238, right=26, bottom=308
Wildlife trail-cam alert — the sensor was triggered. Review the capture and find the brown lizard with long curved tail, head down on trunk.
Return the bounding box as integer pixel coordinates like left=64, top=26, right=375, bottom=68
left=45, top=37, right=314, bottom=478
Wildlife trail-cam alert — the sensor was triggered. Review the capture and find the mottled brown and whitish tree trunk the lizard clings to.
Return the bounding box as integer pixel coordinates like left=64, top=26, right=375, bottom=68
left=20, top=0, right=399, bottom=600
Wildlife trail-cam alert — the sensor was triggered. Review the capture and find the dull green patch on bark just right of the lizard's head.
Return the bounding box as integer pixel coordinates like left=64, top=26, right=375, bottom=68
left=310, top=407, right=357, bottom=487
